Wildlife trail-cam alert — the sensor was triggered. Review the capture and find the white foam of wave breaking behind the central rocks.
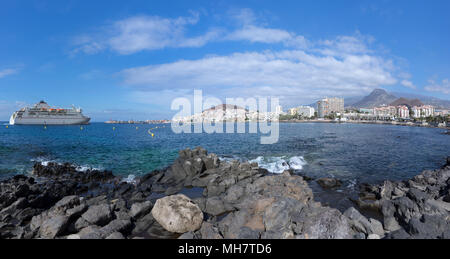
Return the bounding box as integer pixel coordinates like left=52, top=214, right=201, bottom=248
left=250, top=156, right=306, bottom=174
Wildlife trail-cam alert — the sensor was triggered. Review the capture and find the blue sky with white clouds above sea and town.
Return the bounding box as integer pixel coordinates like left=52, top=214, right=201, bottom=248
left=0, top=0, right=450, bottom=121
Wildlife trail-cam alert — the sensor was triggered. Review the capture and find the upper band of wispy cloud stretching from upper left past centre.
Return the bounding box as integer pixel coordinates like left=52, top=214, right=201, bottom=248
left=71, top=9, right=307, bottom=55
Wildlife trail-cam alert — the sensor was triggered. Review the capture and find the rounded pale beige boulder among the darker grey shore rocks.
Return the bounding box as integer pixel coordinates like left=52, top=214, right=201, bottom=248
left=151, top=194, right=203, bottom=233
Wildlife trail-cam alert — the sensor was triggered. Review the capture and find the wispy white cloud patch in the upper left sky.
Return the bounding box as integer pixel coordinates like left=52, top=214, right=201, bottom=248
left=71, top=13, right=225, bottom=55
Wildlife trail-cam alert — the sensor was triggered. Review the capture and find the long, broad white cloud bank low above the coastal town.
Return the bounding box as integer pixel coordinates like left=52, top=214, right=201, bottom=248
left=122, top=44, right=397, bottom=106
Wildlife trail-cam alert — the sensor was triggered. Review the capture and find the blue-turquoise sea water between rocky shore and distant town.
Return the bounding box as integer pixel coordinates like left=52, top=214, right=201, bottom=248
left=0, top=123, right=450, bottom=185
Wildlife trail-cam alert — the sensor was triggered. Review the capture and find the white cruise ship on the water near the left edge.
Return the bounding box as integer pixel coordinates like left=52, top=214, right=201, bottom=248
left=9, top=101, right=91, bottom=125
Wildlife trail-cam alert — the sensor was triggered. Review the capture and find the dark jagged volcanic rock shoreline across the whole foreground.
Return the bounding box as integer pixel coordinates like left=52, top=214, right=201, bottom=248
left=0, top=148, right=450, bottom=239
